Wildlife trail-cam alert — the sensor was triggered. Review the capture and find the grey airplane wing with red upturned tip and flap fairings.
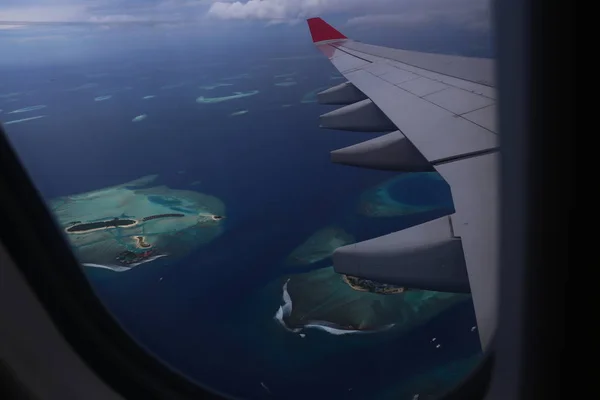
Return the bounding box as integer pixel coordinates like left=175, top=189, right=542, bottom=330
left=307, top=18, right=499, bottom=349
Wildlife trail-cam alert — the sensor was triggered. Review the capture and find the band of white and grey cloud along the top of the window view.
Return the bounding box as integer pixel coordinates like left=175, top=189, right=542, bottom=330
left=0, top=0, right=490, bottom=30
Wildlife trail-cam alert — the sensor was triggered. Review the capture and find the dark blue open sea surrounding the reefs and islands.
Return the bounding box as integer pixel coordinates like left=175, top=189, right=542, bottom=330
left=0, top=28, right=488, bottom=400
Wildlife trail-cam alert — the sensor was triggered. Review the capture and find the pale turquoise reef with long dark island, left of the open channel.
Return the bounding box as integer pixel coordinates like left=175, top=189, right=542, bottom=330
left=49, top=175, right=225, bottom=271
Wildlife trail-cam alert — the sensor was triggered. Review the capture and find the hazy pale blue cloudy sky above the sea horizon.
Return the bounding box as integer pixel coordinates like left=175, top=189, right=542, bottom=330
left=0, top=0, right=490, bottom=65
